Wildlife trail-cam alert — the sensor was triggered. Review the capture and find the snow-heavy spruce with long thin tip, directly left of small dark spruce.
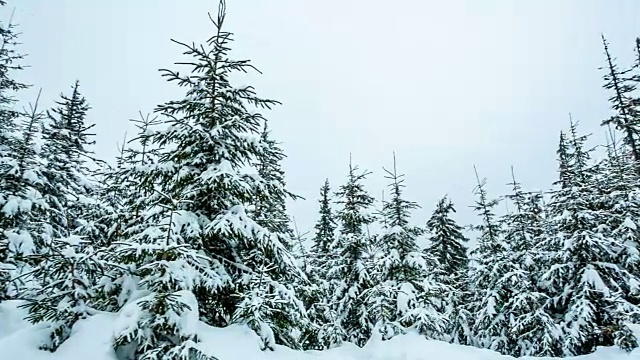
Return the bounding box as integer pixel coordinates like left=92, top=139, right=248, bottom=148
left=367, top=155, right=449, bottom=340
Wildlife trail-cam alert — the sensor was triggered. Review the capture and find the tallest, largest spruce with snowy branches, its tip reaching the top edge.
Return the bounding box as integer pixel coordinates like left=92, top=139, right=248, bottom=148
left=116, top=2, right=306, bottom=348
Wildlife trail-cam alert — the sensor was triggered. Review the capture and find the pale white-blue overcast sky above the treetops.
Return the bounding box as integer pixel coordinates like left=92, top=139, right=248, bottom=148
left=7, top=0, right=640, bottom=231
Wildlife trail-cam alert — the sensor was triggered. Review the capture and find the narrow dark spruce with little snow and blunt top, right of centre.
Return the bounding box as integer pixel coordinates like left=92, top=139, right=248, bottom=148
left=426, top=196, right=472, bottom=345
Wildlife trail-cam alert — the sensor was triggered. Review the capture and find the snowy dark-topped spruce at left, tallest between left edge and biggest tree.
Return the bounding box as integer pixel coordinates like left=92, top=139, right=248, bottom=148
left=25, top=82, right=102, bottom=351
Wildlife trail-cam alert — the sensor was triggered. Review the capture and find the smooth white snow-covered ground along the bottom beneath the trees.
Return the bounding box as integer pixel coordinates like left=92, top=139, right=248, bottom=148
left=0, top=301, right=640, bottom=360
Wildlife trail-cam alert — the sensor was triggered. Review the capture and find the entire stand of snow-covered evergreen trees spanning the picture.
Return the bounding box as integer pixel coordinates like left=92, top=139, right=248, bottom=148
left=0, top=1, right=640, bottom=360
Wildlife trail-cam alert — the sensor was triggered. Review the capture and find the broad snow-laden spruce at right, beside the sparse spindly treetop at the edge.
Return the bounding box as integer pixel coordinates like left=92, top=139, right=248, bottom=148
left=541, top=122, right=637, bottom=355
